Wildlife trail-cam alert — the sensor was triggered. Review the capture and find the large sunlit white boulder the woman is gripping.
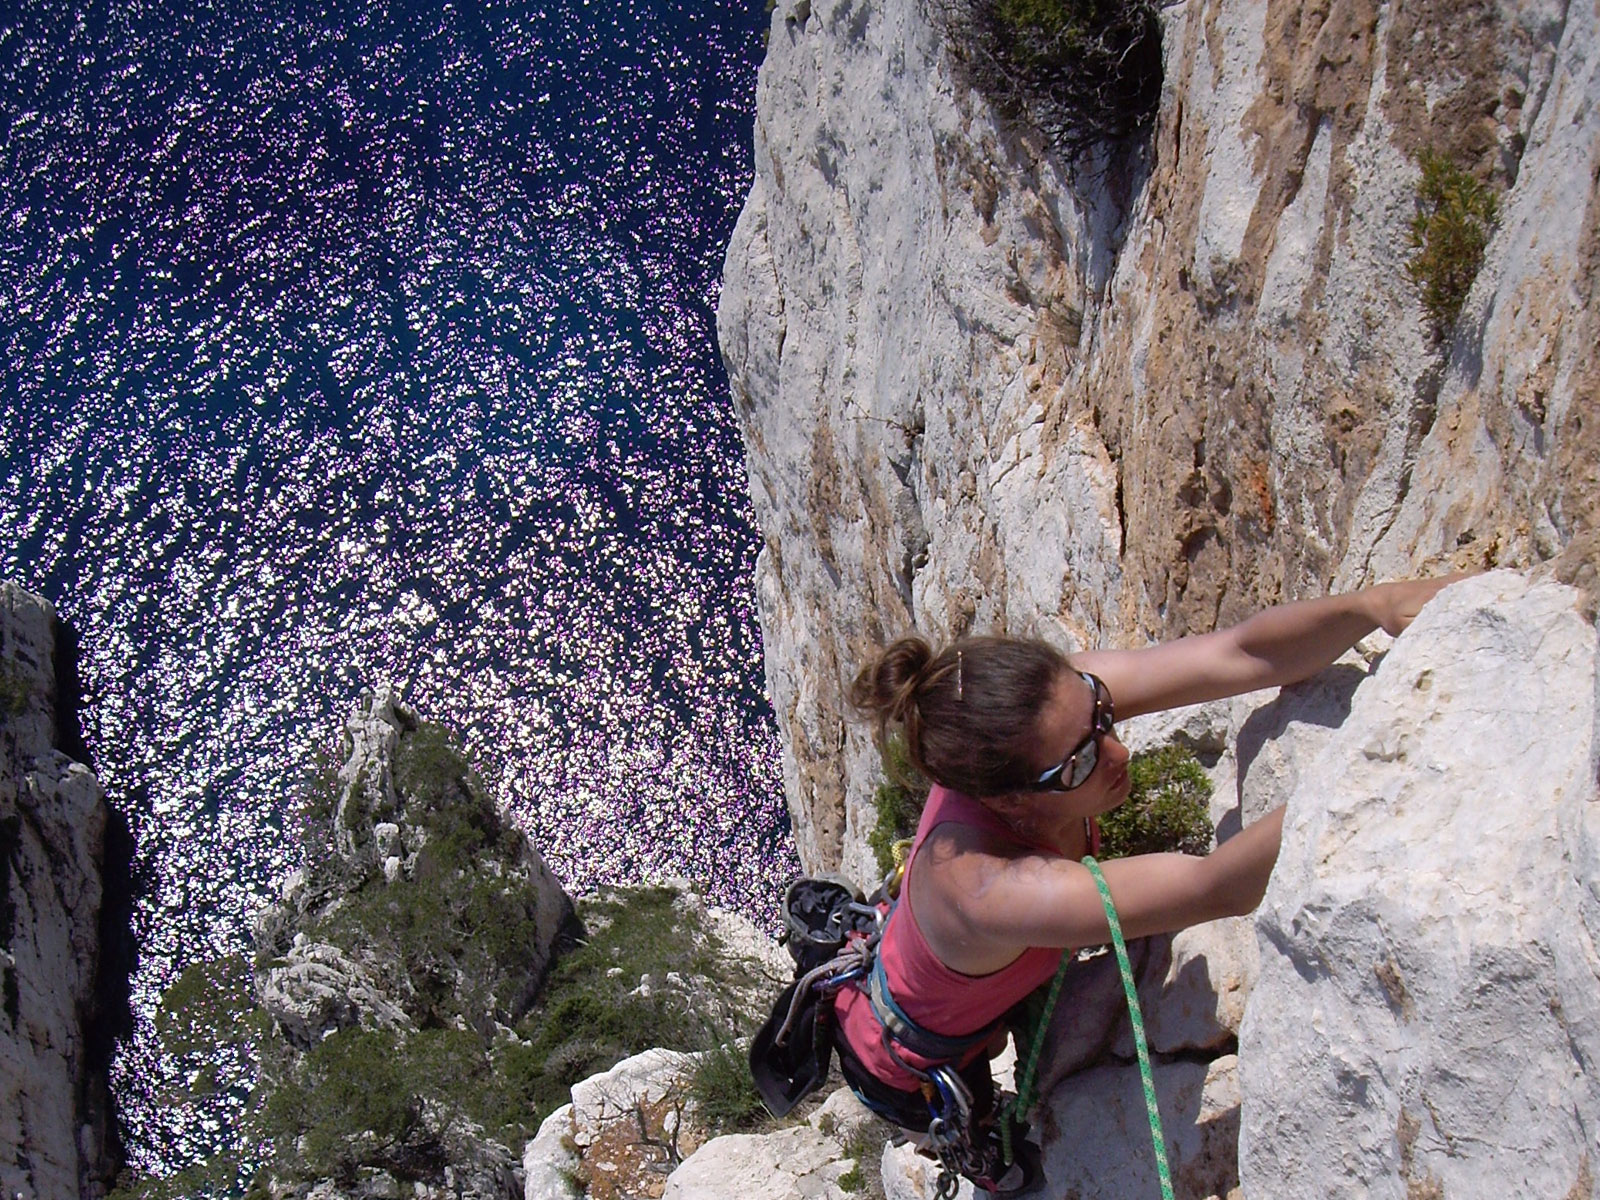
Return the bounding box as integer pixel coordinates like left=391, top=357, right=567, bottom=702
left=1238, top=573, right=1600, bottom=1197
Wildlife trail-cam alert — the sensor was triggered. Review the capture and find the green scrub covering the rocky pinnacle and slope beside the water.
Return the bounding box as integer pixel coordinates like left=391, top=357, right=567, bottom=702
left=115, top=725, right=758, bottom=1200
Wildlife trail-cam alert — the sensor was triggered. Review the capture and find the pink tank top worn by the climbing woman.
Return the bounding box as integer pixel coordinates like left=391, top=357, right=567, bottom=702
left=834, top=784, right=1099, bottom=1091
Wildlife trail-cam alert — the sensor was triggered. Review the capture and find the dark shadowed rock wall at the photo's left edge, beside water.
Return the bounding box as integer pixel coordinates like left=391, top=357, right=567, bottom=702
left=0, top=582, right=125, bottom=1200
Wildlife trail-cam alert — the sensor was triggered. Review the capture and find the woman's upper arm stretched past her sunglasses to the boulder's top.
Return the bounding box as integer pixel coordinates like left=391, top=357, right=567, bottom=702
left=1072, top=574, right=1464, bottom=717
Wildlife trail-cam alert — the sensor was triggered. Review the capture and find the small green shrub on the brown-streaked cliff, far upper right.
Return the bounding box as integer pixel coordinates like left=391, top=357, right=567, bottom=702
left=1406, top=150, right=1499, bottom=336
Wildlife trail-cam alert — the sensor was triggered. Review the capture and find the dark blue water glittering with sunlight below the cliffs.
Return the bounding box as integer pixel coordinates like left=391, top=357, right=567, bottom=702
left=0, top=0, right=794, bottom=1170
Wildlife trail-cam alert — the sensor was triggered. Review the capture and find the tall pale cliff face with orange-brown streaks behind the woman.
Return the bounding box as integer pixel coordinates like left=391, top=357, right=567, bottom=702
left=718, top=0, right=1600, bottom=878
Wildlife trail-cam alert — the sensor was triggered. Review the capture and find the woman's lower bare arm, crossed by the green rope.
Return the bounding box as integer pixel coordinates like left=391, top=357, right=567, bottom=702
left=965, top=808, right=1283, bottom=949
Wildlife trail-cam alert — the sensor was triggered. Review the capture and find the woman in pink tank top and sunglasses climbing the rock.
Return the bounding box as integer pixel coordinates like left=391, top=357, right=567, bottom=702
left=834, top=579, right=1453, bottom=1194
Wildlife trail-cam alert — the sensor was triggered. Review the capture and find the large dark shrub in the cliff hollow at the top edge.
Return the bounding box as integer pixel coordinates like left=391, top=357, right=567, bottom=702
left=942, top=0, right=1162, bottom=158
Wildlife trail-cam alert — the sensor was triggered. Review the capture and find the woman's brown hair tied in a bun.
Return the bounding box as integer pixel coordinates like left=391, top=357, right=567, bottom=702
left=850, top=637, right=1067, bottom=797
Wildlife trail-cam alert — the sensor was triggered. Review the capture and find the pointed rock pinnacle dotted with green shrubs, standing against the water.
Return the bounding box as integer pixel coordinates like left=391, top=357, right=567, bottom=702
left=256, top=690, right=571, bottom=1200
